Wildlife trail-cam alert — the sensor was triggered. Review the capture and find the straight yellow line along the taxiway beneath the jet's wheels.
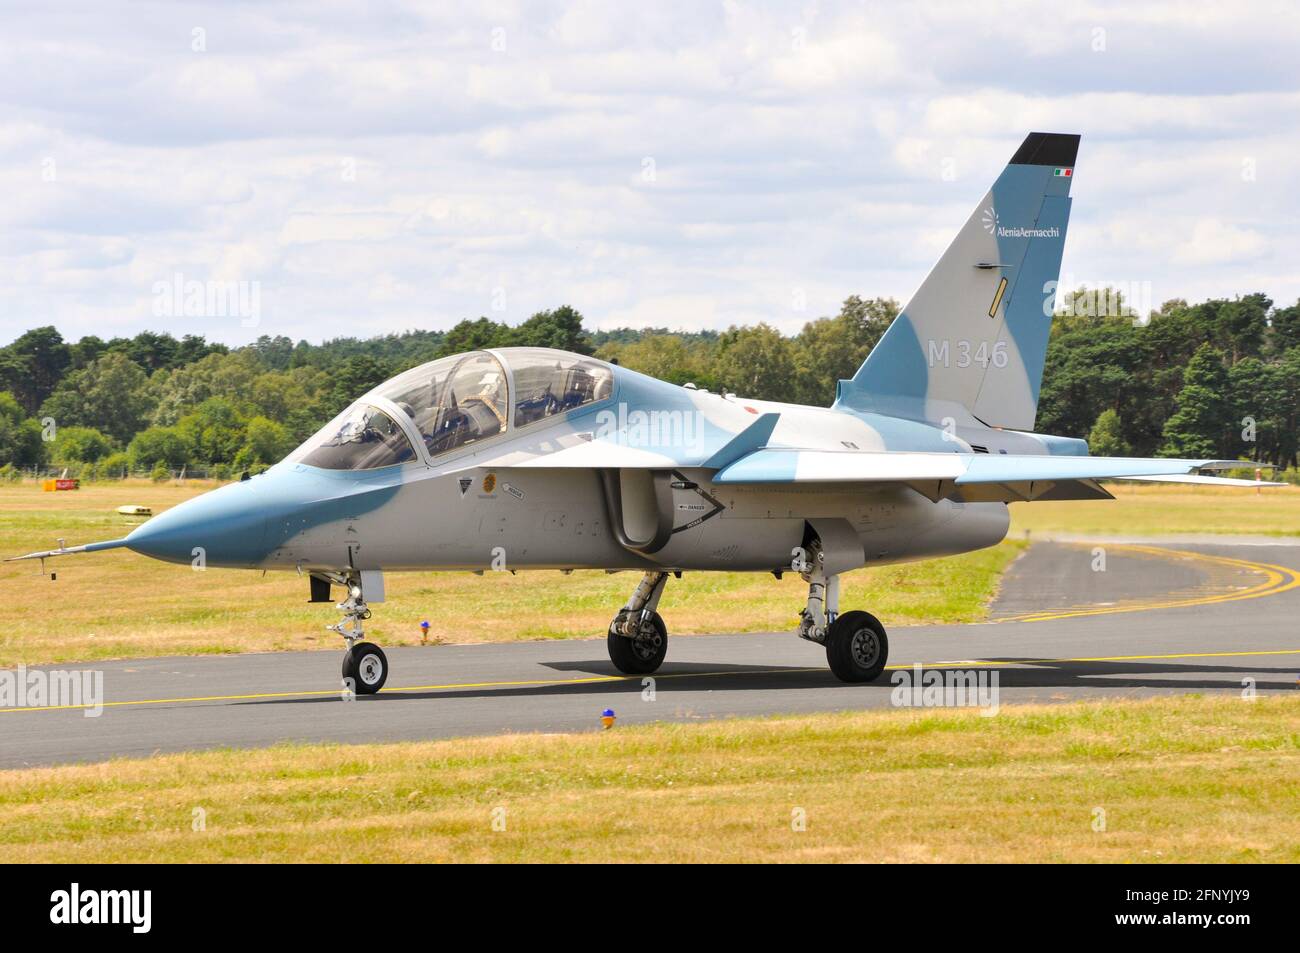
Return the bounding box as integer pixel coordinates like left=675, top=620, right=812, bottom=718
left=0, top=649, right=1300, bottom=715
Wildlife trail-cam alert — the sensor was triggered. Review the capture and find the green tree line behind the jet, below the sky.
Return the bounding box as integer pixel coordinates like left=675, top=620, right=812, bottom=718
left=0, top=289, right=1300, bottom=477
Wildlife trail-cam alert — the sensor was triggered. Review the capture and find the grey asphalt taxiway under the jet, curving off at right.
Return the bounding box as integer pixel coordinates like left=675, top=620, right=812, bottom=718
left=0, top=541, right=1300, bottom=768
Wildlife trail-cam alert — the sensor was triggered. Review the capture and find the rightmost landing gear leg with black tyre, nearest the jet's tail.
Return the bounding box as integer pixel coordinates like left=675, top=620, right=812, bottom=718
left=792, top=545, right=889, bottom=683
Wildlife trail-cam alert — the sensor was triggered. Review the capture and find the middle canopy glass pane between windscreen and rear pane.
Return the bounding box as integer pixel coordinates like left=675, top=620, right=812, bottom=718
left=384, top=351, right=507, bottom=456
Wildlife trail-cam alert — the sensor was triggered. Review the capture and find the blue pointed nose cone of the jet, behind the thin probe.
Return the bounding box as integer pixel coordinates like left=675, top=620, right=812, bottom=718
left=126, top=481, right=267, bottom=566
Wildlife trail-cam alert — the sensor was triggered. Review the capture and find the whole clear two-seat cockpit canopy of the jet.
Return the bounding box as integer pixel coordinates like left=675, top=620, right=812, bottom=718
left=287, top=347, right=614, bottom=469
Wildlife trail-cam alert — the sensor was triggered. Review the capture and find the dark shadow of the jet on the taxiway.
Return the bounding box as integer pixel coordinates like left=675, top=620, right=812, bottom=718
left=238, top=658, right=1297, bottom=705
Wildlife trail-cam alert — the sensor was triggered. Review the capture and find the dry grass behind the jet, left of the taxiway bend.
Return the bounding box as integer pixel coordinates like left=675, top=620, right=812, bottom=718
left=0, top=481, right=1024, bottom=666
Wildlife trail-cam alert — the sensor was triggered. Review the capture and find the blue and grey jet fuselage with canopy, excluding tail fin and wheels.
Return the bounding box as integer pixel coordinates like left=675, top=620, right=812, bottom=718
left=119, top=348, right=1070, bottom=572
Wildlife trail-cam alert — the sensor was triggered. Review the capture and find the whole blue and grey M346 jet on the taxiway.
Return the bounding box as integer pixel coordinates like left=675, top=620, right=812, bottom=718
left=7, top=133, right=1279, bottom=694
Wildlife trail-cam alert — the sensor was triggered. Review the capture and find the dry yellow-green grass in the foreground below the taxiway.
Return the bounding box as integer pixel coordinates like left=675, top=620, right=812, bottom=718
left=0, top=696, right=1300, bottom=863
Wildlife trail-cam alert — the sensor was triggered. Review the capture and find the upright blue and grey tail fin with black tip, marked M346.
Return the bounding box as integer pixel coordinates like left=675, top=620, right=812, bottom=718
left=836, top=133, right=1079, bottom=430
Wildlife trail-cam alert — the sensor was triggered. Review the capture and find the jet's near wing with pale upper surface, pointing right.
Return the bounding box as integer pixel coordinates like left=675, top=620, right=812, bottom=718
left=712, top=447, right=1281, bottom=502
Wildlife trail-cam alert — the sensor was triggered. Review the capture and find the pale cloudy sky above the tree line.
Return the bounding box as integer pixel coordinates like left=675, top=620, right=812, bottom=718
left=0, top=0, right=1300, bottom=343
